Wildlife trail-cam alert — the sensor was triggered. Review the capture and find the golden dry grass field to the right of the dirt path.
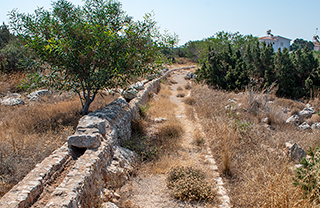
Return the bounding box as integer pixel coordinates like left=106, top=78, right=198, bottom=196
left=192, top=83, right=319, bottom=207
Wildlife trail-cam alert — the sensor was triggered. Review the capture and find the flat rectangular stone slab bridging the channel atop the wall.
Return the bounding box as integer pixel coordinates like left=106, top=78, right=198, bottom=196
left=68, top=133, right=103, bottom=149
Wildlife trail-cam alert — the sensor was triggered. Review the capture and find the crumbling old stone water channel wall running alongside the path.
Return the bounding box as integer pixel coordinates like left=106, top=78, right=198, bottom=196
left=0, top=66, right=194, bottom=208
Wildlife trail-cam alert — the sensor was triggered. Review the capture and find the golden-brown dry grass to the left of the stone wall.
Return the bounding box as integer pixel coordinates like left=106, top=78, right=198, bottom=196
left=0, top=91, right=114, bottom=196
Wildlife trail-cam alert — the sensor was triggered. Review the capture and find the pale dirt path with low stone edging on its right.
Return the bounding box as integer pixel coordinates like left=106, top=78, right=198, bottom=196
left=121, top=70, right=230, bottom=208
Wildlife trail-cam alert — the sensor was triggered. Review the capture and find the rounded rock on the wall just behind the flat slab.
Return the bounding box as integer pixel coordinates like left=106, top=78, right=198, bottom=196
left=77, top=113, right=106, bottom=135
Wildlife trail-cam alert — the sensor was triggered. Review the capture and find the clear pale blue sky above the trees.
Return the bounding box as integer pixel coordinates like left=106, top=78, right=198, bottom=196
left=0, top=0, right=320, bottom=45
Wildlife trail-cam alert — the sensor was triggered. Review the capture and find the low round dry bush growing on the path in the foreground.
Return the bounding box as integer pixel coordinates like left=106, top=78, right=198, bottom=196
left=167, top=167, right=215, bottom=201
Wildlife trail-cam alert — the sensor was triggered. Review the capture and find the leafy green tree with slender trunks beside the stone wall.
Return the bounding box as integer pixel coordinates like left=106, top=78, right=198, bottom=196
left=9, top=0, right=177, bottom=114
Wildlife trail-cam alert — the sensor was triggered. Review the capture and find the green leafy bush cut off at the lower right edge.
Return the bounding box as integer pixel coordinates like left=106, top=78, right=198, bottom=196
left=294, top=147, right=320, bottom=203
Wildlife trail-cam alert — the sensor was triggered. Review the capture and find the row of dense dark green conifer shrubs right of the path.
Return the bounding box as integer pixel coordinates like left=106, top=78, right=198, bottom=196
left=196, top=32, right=320, bottom=99
